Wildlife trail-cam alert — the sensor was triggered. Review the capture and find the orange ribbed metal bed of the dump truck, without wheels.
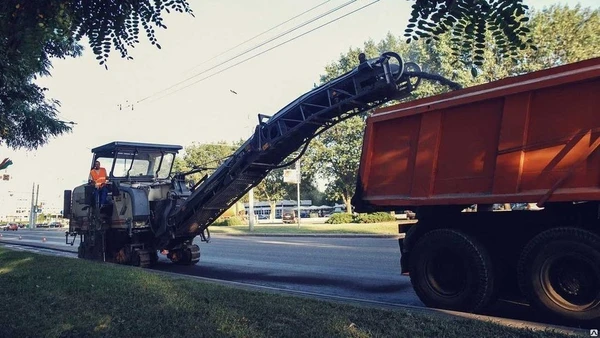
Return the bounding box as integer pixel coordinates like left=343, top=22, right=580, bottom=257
left=353, top=58, right=600, bottom=212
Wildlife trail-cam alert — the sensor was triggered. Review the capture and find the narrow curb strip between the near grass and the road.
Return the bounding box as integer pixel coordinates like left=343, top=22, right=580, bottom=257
left=0, top=240, right=589, bottom=337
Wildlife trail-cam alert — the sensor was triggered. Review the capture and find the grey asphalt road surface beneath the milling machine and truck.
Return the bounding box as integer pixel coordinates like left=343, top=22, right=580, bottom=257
left=0, top=229, right=580, bottom=324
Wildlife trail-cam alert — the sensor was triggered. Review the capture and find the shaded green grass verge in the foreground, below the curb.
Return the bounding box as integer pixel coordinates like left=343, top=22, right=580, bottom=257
left=0, top=248, right=584, bottom=338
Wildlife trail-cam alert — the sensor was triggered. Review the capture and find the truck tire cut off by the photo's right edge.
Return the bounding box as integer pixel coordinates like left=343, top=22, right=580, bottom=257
left=517, top=228, right=600, bottom=321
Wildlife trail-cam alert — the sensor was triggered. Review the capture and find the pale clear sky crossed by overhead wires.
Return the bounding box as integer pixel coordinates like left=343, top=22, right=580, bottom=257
left=0, top=0, right=598, bottom=213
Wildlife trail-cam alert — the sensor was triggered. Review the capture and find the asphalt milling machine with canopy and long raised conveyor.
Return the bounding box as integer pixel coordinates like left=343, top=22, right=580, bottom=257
left=64, top=52, right=459, bottom=267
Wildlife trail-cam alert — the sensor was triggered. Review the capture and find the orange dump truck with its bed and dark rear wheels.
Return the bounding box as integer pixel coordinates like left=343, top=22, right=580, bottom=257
left=353, top=58, right=600, bottom=321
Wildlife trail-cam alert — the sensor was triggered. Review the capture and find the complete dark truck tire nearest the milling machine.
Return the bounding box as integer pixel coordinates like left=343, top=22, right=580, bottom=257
left=409, top=229, right=495, bottom=312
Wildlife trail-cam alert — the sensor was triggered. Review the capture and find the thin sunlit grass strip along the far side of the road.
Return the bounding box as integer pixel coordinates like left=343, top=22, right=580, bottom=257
left=209, top=222, right=408, bottom=235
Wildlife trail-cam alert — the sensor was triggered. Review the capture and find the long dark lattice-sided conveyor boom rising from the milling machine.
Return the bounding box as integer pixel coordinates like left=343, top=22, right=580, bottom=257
left=170, top=53, right=422, bottom=238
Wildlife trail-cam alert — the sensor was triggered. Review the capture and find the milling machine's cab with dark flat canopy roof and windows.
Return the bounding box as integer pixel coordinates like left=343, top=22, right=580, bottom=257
left=92, top=141, right=182, bottom=182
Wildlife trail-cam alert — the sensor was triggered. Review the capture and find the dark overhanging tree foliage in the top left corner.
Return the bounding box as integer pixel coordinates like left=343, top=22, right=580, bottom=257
left=0, top=0, right=191, bottom=149
